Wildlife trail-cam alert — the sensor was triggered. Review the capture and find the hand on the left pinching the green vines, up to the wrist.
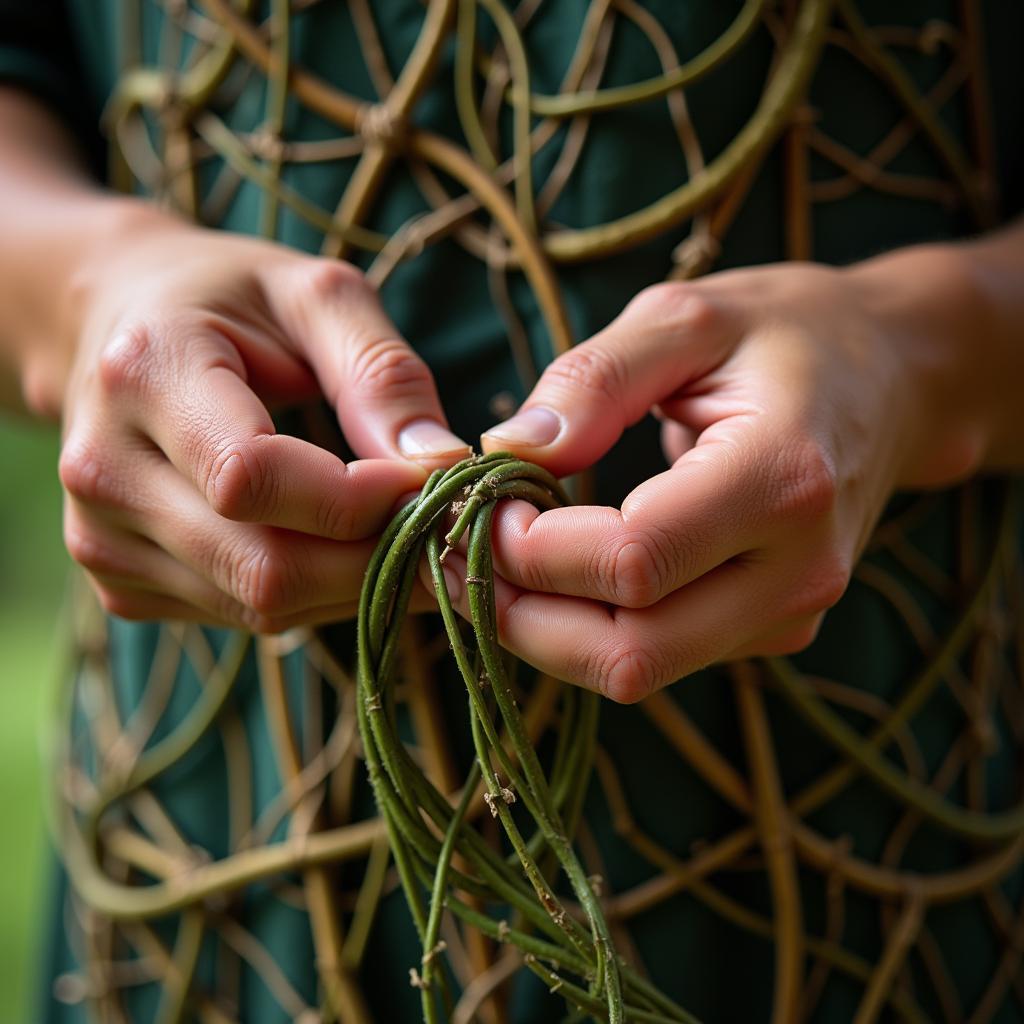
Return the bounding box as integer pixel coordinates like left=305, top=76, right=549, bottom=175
left=60, top=204, right=469, bottom=632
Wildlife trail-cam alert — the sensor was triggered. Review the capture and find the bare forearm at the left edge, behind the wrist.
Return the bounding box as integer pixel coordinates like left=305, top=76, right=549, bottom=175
left=0, top=89, right=168, bottom=419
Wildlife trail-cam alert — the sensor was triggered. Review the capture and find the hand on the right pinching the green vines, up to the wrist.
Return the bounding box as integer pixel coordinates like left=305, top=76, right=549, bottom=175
left=450, top=265, right=981, bottom=701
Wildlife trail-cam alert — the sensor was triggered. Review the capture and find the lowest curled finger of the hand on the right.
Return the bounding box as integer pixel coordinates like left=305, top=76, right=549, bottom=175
left=445, top=553, right=800, bottom=703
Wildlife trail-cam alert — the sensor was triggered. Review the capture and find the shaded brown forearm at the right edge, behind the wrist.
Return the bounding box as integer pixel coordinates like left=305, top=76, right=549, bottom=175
left=847, top=222, right=1024, bottom=485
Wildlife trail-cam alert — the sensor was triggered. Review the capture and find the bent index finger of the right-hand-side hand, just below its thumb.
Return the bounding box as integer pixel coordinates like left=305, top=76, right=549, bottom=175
left=493, top=407, right=846, bottom=608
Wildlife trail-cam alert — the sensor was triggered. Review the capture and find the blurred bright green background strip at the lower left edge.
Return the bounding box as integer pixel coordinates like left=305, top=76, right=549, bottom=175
left=0, top=419, right=68, bottom=1024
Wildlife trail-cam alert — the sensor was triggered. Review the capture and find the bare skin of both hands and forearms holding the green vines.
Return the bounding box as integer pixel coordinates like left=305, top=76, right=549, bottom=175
left=6, top=94, right=1024, bottom=679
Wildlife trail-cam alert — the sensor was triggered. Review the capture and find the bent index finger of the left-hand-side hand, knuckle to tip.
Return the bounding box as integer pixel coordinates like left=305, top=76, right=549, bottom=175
left=100, top=319, right=423, bottom=540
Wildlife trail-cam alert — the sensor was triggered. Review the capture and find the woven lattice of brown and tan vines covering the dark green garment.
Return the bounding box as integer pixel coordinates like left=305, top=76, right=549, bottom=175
left=55, top=0, right=1024, bottom=1024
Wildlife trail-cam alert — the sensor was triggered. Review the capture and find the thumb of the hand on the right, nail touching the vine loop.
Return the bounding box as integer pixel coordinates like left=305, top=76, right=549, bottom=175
left=482, top=283, right=727, bottom=476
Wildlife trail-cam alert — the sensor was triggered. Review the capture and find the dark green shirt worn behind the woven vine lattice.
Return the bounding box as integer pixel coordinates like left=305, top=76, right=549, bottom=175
left=8, top=0, right=1024, bottom=1024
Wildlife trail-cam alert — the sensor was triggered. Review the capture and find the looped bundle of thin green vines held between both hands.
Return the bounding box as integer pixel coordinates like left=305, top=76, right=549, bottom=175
left=357, top=453, right=692, bottom=1024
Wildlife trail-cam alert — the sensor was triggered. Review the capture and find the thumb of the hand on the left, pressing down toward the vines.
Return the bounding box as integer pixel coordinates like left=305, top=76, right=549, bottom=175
left=267, top=260, right=471, bottom=469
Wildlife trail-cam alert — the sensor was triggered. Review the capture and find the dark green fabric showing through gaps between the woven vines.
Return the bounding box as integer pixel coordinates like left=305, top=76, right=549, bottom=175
left=0, top=0, right=1024, bottom=1024
